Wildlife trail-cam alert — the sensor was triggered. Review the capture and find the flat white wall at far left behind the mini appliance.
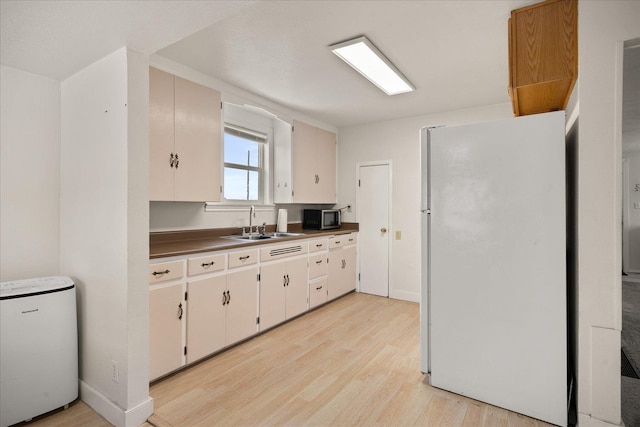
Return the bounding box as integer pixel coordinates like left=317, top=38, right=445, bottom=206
left=0, top=65, right=60, bottom=281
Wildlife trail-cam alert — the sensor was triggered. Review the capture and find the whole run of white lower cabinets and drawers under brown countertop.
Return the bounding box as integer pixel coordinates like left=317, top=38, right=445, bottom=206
left=149, top=233, right=356, bottom=380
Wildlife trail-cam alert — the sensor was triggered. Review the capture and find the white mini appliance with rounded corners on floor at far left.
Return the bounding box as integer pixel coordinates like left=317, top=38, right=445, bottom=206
left=0, top=277, right=78, bottom=427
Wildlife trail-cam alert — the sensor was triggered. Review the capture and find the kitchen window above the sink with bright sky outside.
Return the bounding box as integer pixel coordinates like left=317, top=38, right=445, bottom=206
left=222, top=123, right=267, bottom=203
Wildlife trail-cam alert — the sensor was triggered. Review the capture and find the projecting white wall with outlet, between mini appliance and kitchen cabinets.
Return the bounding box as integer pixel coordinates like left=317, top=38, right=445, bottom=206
left=60, top=48, right=153, bottom=426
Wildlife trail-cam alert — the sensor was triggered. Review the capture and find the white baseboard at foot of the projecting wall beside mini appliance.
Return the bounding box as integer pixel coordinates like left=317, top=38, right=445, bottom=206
left=80, top=381, right=153, bottom=427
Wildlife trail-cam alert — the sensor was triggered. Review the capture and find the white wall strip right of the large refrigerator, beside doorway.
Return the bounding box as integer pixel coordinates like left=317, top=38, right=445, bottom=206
left=577, top=1, right=640, bottom=426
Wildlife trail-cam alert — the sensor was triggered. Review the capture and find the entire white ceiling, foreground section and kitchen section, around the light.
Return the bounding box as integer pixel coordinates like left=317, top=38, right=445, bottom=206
left=0, top=0, right=637, bottom=132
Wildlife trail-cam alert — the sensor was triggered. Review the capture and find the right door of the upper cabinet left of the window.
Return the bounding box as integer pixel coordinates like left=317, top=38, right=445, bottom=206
left=174, top=77, right=221, bottom=202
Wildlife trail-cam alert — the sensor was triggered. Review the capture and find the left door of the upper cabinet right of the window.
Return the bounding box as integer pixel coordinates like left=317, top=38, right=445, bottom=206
left=293, top=121, right=317, bottom=203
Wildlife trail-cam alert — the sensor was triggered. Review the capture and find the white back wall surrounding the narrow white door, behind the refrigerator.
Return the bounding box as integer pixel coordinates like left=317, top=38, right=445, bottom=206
left=338, top=103, right=513, bottom=302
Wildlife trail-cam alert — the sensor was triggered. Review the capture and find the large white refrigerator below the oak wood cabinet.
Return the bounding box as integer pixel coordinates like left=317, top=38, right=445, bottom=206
left=420, top=112, right=567, bottom=426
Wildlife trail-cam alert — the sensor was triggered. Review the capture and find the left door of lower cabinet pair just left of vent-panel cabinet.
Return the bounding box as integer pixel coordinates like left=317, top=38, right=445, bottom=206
left=187, top=276, right=227, bottom=363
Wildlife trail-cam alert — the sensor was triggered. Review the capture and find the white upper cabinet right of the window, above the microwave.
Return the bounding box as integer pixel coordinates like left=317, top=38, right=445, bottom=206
left=274, top=120, right=336, bottom=204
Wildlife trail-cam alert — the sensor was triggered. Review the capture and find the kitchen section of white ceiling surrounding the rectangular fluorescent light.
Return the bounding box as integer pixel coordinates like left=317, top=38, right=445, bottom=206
left=158, top=1, right=535, bottom=126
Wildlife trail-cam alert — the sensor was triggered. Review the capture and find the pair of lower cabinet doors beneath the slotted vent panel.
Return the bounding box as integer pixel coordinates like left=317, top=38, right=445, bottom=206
left=260, top=257, right=307, bottom=331
